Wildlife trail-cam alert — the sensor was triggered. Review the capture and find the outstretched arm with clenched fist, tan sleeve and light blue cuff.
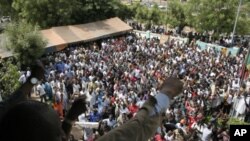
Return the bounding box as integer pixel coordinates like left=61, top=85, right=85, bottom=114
left=98, top=78, right=183, bottom=141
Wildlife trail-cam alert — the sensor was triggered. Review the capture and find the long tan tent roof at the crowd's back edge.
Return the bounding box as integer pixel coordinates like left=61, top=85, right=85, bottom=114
left=41, top=17, right=132, bottom=47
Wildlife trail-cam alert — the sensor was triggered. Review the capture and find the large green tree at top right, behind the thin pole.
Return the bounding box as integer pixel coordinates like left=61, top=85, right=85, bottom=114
left=187, top=0, right=249, bottom=34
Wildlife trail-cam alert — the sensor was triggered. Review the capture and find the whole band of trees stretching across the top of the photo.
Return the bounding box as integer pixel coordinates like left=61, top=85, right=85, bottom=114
left=0, top=0, right=250, bottom=34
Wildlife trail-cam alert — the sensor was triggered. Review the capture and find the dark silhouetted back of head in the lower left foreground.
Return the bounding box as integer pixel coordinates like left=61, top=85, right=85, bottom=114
left=0, top=101, right=62, bottom=141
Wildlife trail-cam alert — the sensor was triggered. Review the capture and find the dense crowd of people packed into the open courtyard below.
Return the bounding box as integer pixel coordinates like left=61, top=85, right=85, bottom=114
left=16, top=34, right=250, bottom=141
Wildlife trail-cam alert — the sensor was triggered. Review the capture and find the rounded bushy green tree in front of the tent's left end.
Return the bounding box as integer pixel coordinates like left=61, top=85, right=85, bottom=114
left=3, top=21, right=47, bottom=65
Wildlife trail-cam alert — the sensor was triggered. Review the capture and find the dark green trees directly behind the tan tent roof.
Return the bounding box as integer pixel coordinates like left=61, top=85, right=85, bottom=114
left=10, top=0, right=129, bottom=28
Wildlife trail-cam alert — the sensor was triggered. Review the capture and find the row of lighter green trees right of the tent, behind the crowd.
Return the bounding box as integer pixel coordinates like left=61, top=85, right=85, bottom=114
left=128, top=0, right=250, bottom=35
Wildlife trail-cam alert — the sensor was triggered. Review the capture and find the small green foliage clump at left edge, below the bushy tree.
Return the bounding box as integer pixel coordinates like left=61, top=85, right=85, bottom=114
left=0, top=61, right=20, bottom=99
